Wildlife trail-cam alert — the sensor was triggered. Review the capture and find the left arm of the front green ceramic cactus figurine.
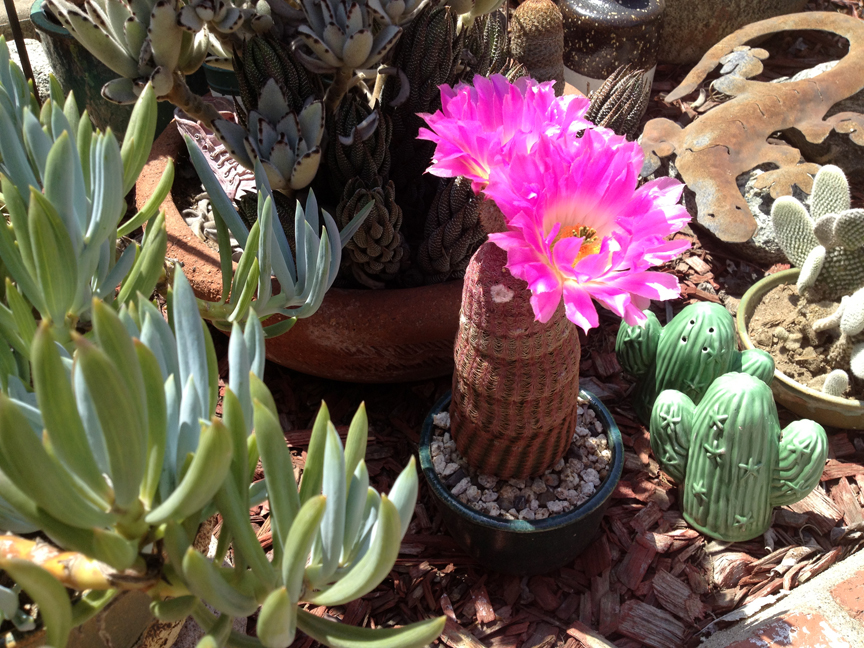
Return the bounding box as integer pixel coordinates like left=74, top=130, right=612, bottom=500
left=650, top=389, right=696, bottom=483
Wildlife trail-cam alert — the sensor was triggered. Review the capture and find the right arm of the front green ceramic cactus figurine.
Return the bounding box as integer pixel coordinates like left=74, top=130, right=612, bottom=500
left=771, top=419, right=828, bottom=506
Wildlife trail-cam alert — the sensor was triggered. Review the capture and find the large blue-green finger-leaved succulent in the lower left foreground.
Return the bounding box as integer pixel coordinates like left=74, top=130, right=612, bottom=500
left=0, top=271, right=442, bottom=648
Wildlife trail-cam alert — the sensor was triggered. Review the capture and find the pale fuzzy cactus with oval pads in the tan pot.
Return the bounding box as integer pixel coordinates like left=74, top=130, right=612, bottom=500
left=771, top=165, right=864, bottom=396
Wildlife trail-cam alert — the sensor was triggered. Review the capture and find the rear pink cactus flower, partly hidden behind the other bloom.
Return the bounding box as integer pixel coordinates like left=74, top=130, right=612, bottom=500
left=418, top=75, right=593, bottom=191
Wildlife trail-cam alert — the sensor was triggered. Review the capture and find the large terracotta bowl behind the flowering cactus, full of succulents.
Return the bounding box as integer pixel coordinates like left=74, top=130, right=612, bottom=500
left=135, top=123, right=462, bottom=383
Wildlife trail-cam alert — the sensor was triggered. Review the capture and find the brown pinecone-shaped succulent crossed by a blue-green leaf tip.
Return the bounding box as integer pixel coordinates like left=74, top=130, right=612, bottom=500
left=336, top=178, right=405, bottom=288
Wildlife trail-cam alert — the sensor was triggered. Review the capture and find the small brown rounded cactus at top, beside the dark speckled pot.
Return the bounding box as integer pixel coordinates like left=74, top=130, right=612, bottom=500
left=510, top=0, right=564, bottom=94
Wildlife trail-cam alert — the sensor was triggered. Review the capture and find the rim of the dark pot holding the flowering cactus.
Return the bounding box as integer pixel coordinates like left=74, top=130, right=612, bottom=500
left=419, top=389, right=624, bottom=533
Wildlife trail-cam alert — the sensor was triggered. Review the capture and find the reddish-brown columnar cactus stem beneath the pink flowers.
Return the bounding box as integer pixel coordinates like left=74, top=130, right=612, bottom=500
left=450, top=242, right=579, bottom=479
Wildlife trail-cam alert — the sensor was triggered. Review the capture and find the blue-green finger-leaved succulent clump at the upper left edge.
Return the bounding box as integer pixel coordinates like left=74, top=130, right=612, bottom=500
left=0, top=40, right=174, bottom=344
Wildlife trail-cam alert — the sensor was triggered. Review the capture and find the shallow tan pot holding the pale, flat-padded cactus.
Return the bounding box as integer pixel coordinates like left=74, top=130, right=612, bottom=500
left=735, top=268, right=864, bottom=430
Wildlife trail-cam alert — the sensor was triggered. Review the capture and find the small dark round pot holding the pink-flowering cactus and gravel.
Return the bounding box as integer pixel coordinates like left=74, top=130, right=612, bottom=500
left=420, top=390, right=624, bottom=575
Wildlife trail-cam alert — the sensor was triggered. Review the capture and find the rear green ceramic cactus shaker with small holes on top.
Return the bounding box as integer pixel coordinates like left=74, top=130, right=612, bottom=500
left=615, top=302, right=774, bottom=423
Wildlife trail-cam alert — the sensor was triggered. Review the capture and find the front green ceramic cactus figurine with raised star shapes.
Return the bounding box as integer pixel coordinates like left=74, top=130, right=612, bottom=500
left=650, top=372, right=828, bottom=542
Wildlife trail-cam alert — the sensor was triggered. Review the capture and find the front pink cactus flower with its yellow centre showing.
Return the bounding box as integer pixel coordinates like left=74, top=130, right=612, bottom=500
left=485, top=129, right=690, bottom=332
